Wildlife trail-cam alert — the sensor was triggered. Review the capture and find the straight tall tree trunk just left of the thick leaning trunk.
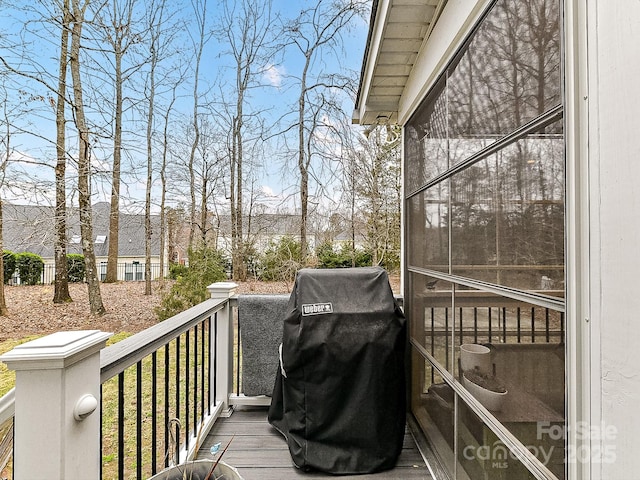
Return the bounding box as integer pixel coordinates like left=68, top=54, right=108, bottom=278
left=53, top=0, right=72, bottom=303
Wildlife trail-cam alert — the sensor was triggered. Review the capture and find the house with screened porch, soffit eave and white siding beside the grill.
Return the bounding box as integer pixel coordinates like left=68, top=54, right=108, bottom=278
left=354, top=0, right=640, bottom=480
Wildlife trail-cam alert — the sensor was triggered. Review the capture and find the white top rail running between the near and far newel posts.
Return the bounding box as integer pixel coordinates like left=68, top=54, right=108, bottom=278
left=100, top=298, right=229, bottom=383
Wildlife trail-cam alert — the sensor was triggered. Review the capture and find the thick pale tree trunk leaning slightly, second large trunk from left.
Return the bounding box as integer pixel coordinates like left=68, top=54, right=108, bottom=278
left=69, top=0, right=105, bottom=315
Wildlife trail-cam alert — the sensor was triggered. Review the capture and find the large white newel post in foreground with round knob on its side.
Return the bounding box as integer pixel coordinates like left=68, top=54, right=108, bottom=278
left=0, top=330, right=111, bottom=480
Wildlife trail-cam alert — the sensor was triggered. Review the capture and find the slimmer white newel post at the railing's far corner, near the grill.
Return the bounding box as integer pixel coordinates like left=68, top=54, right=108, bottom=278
left=207, top=282, right=238, bottom=415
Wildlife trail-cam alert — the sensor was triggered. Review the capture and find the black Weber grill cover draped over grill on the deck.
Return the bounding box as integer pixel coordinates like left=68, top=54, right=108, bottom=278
left=269, top=267, right=406, bottom=474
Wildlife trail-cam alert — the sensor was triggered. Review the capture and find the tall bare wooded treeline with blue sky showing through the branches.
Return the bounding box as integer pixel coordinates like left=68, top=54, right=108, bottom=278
left=0, top=0, right=400, bottom=314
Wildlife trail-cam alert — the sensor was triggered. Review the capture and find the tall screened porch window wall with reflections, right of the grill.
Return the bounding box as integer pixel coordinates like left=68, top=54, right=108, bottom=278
left=404, top=0, right=566, bottom=480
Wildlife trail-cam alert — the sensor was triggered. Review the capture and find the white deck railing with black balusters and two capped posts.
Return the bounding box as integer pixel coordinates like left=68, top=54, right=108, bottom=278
left=0, top=282, right=241, bottom=480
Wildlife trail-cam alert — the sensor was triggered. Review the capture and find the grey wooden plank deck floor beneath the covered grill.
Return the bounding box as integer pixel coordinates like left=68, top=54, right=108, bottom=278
left=198, top=408, right=433, bottom=480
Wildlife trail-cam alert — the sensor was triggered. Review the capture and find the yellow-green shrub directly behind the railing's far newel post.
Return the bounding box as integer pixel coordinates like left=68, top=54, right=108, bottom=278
left=155, top=248, right=226, bottom=320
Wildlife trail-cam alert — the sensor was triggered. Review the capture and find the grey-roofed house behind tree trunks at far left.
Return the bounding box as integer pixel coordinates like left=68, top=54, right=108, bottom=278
left=2, top=202, right=168, bottom=283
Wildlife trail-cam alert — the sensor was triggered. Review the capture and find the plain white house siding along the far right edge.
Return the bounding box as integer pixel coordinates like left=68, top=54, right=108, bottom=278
left=584, top=0, right=640, bottom=479
